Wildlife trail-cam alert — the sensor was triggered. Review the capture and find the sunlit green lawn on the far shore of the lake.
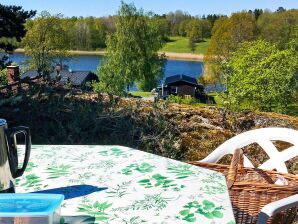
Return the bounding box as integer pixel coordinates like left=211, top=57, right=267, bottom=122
left=161, top=37, right=210, bottom=54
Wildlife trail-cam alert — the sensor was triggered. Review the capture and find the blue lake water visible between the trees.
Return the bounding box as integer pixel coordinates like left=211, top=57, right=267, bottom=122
left=10, top=53, right=203, bottom=78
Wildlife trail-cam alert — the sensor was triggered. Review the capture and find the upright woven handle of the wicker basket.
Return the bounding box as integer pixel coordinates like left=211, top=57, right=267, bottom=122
left=227, top=149, right=244, bottom=189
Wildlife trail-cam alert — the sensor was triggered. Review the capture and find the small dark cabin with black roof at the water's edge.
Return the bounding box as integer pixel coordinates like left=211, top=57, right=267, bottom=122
left=158, top=75, right=205, bottom=99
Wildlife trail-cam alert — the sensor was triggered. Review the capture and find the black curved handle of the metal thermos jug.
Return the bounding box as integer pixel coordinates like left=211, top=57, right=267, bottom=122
left=5, top=126, right=31, bottom=178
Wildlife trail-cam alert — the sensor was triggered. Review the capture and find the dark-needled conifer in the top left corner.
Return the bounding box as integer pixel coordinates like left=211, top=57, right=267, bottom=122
left=0, top=4, right=36, bottom=70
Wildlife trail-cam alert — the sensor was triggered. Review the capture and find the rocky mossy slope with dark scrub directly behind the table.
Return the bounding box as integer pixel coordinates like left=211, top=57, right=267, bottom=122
left=0, top=85, right=298, bottom=173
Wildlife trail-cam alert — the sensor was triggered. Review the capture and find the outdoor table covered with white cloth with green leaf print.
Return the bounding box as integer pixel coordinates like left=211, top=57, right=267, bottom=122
left=16, top=145, right=235, bottom=224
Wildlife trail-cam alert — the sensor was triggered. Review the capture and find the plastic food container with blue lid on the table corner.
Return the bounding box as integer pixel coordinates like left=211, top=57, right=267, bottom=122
left=0, top=193, right=64, bottom=224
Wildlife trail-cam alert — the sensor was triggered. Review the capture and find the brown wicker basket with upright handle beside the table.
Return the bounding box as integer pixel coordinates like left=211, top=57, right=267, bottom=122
left=189, top=149, right=298, bottom=224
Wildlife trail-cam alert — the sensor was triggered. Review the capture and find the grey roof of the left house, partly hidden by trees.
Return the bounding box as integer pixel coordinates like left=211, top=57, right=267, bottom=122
left=21, top=70, right=91, bottom=86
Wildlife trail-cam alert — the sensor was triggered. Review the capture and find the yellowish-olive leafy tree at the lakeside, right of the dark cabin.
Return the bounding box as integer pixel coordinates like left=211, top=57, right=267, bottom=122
left=203, top=12, right=257, bottom=84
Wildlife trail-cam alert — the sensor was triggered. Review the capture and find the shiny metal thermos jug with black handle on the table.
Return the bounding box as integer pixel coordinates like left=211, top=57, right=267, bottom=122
left=0, top=119, right=31, bottom=193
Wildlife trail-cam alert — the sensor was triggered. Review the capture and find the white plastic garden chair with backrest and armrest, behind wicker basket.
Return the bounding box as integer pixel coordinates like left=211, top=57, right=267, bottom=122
left=200, top=128, right=298, bottom=224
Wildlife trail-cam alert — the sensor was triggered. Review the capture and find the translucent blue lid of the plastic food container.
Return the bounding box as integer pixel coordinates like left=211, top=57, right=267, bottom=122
left=0, top=193, right=64, bottom=217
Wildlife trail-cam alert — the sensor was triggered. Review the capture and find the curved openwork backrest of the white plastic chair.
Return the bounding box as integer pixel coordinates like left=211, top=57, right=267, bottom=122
left=200, top=128, right=298, bottom=173
